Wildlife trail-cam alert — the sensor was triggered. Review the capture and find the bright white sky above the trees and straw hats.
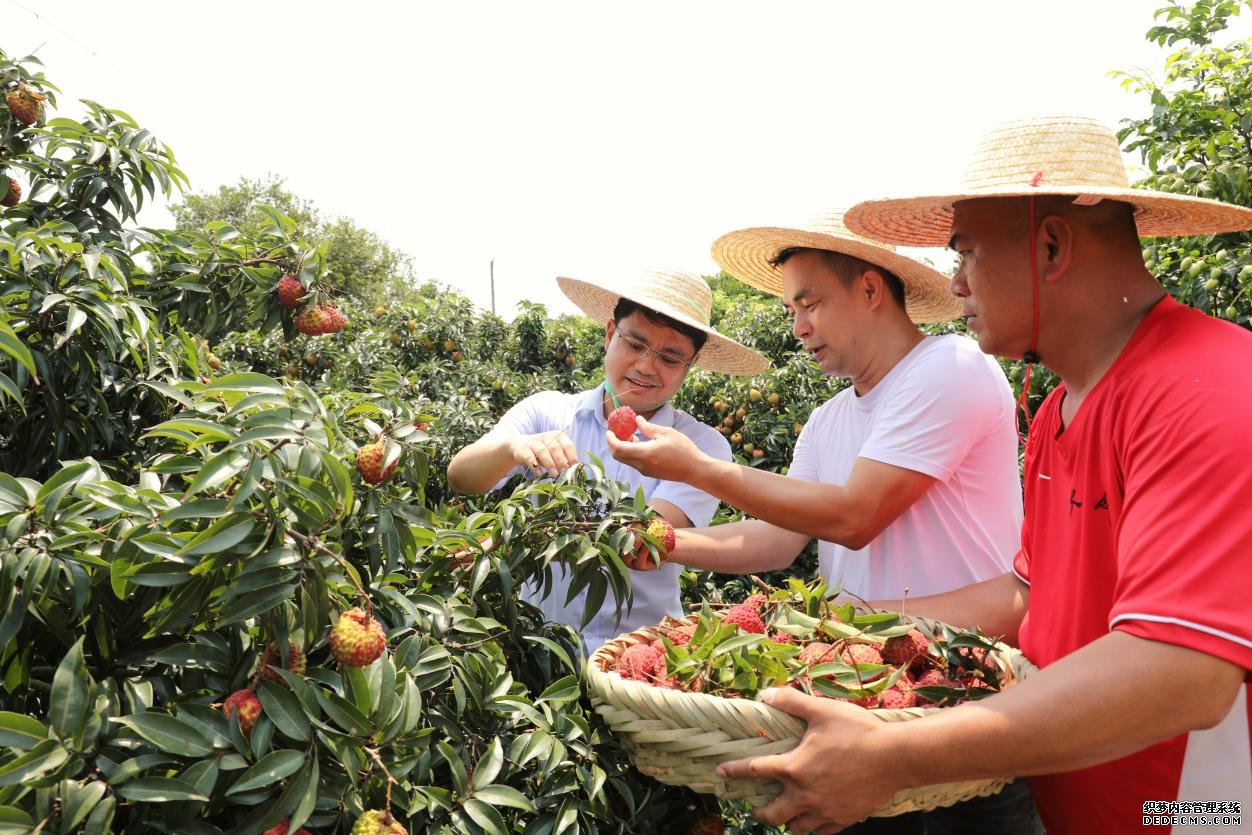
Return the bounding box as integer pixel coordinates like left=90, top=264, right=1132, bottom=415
left=7, top=0, right=1252, bottom=317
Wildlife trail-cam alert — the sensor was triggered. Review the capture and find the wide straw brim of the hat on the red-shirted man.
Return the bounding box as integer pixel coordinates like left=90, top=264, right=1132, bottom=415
left=844, top=185, right=1252, bottom=247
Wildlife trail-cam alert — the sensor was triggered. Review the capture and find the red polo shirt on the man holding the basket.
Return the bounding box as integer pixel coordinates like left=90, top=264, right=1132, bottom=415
left=1014, top=295, right=1252, bottom=835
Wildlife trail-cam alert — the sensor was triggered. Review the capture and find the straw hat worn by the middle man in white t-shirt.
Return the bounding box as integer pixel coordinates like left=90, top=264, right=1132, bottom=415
left=712, top=212, right=960, bottom=322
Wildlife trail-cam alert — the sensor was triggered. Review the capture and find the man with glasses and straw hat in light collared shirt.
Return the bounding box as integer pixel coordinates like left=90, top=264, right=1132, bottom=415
left=448, top=273, right=769, bottom=652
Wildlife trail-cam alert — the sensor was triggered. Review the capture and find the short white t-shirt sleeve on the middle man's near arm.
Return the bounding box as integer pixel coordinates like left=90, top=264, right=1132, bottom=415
left=860, top=344, right=1013, bottom=481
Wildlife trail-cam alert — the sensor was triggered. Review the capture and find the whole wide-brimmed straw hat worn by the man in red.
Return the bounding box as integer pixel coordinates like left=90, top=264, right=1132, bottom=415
left=844, top=115, right=1252, bottom=247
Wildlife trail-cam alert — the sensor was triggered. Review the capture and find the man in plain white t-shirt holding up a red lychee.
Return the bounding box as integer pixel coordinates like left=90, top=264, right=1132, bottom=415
left=606, top=215, right=1042, bottom=835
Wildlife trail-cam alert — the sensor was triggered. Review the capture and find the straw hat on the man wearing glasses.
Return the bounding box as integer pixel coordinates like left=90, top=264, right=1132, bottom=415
left=556, top=270, right=770, bottom=374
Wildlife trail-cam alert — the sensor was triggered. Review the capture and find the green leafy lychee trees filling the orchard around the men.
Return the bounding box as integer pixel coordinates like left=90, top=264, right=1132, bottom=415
left=0, top=0, right=1252, bottom=834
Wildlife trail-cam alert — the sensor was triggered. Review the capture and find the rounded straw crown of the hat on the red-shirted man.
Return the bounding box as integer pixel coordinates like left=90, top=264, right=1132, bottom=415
left=962, top=116, right=1131, bottom=193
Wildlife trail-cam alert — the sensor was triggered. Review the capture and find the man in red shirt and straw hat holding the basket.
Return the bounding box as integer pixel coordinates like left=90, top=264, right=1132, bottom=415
left=722, top=118, right=1252, bottom=835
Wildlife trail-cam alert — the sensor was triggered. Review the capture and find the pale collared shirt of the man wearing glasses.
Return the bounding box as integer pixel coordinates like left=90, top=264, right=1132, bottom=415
left=483, top=386, right=731, bottom=653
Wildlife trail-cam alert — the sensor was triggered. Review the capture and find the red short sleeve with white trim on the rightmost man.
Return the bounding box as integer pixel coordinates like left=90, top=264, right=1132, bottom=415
left=1109, top=388, right=1252, bottom=670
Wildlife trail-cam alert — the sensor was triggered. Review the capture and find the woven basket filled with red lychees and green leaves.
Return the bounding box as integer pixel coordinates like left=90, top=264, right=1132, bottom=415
left=587, top=580, right=1035, bottom=816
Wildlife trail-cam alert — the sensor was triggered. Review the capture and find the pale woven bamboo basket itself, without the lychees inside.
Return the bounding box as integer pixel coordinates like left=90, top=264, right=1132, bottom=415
left=586, top=615, right=1037, bottom=817
